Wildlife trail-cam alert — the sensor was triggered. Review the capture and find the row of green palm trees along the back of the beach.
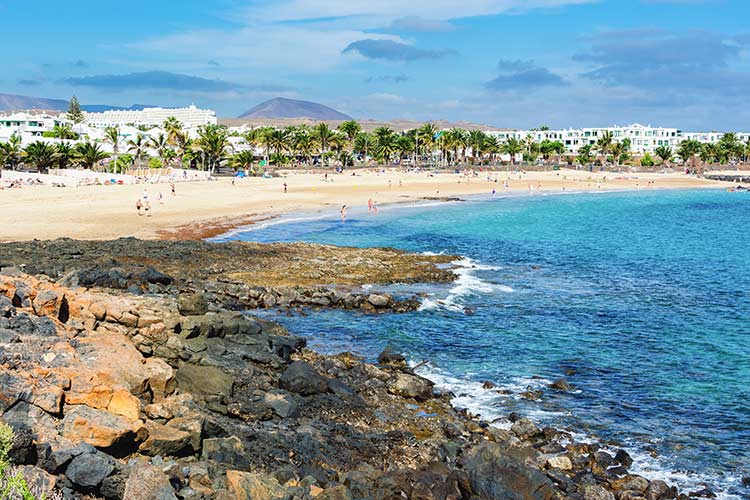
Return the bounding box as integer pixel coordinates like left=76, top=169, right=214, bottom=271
left=0, top=117, right=750, bottom=172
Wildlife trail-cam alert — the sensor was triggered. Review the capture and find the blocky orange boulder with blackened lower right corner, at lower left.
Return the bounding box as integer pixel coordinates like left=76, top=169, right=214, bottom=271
left=62, top=406, right=146, bottom=453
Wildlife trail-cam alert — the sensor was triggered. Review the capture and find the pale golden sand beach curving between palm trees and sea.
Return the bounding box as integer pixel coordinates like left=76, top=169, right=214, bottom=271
left=0, top=169, right=729, bottom=241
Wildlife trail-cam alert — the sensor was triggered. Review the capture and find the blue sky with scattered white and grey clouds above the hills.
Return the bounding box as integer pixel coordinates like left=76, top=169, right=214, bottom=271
left=0, top=0, right=750, bottom=131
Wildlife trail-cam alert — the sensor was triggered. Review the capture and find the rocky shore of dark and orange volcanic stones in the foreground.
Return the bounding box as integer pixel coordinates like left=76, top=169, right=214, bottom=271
left=0, top=240, right=687, bottom=500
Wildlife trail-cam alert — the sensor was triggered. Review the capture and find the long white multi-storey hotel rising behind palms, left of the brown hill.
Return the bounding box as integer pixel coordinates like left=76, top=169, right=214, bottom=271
left=85, top=105, right=217, bottom=128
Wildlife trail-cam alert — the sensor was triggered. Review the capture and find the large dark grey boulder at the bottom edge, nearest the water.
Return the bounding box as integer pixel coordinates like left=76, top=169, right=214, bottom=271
left=463, top=443, right=560, bottom=500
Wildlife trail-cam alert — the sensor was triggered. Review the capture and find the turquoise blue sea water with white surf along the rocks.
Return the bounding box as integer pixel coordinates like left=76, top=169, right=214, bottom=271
left=220, top=190, right=750, bottom=498
